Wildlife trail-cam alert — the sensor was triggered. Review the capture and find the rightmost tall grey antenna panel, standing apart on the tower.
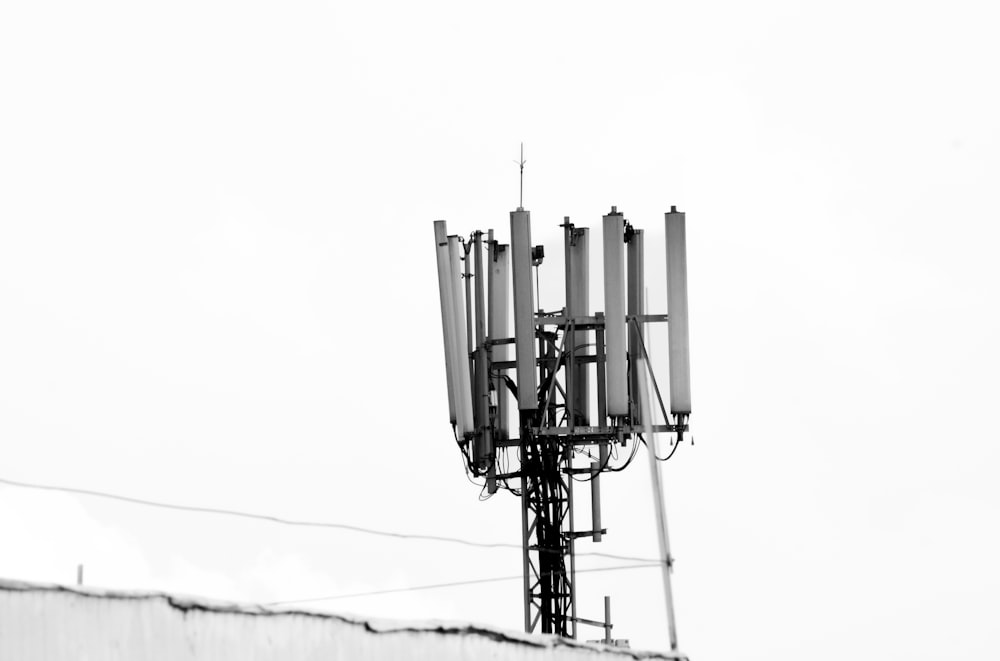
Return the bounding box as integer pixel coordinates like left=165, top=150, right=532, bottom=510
left=665, top=211, right=691, bottom=415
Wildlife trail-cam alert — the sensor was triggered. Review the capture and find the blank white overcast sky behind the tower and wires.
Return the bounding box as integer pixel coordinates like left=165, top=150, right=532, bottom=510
left=0, top=0, right=1000, bottom=661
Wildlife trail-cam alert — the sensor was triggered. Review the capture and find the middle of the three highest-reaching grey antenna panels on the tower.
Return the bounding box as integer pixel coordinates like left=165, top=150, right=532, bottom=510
left=604, top=210, right=628, bottom=416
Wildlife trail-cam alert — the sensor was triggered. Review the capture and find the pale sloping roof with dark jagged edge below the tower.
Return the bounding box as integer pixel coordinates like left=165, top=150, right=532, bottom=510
left=0, top=579, right=685, bottom=661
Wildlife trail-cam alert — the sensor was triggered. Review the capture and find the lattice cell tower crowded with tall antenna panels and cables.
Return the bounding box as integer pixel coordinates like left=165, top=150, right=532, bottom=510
left=434, top=195, right=691, bottom=649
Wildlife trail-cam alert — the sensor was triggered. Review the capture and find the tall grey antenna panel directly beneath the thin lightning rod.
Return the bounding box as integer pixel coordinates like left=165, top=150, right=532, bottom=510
left=510, top=210, right=538, bottom=411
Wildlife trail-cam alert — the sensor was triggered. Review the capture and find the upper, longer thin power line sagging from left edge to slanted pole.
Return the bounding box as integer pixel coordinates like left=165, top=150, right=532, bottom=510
left=0, top=477, right=658, bottom=563
